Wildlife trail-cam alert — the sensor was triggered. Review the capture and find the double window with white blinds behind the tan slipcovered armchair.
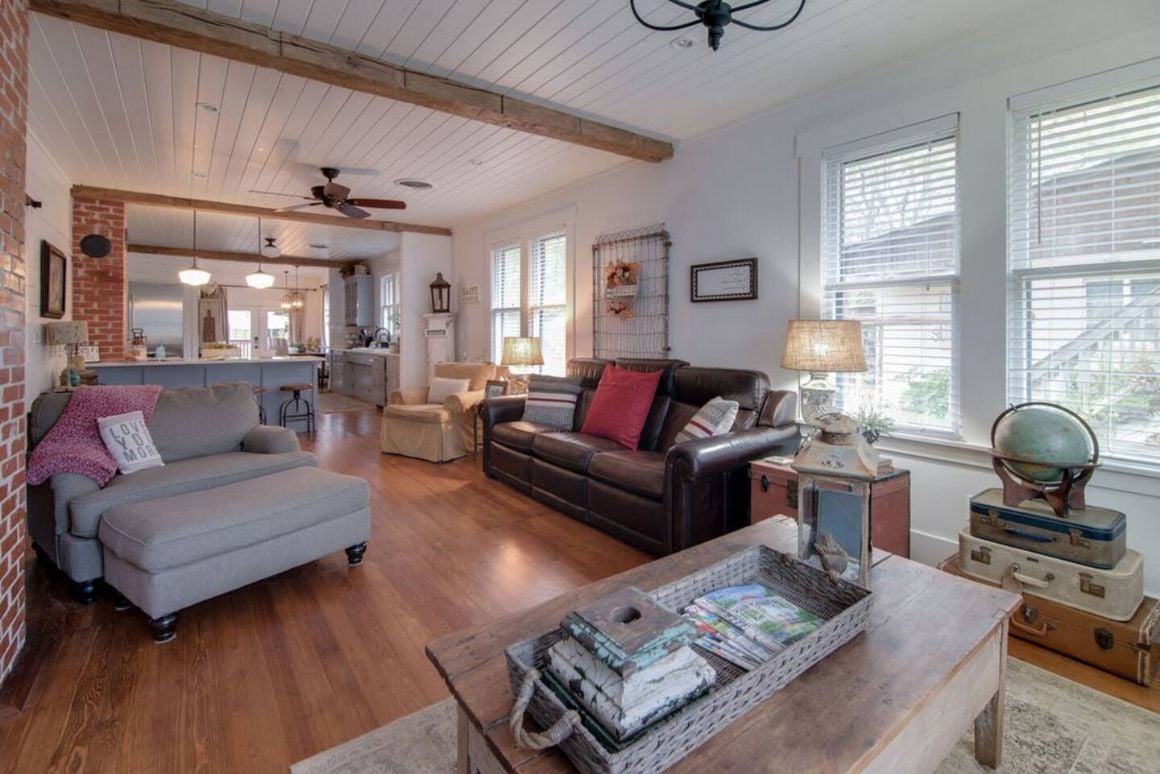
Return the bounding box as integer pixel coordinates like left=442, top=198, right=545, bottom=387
left=492, top=233, right=568, bottom=376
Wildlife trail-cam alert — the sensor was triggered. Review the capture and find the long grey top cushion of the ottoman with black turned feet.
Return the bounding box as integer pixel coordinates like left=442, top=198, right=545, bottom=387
left=100, top=468, right=370, bottom=573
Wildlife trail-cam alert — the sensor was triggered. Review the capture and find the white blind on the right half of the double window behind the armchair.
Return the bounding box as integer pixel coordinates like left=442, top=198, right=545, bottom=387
left=528, top=233, right=567, bottom=375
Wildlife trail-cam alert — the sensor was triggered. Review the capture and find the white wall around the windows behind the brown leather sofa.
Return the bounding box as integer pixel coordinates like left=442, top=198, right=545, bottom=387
left=454, top=0, right=1160, bottom=593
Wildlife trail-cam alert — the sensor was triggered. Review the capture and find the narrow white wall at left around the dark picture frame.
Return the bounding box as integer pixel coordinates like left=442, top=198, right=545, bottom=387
left=24, top=133, right=73, bottom=411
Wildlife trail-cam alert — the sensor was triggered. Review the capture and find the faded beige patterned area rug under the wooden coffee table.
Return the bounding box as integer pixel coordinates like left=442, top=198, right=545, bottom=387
left=290, top=659, right=1160, bottom=774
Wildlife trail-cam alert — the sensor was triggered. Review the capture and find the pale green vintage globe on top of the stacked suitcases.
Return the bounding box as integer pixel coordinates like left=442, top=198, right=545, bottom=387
left=991, top=404, right=1099, bottom=484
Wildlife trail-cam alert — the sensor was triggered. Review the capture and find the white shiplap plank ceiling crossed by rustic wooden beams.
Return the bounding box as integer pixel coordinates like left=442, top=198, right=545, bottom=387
left=29, top=0, right=1034, bottom=258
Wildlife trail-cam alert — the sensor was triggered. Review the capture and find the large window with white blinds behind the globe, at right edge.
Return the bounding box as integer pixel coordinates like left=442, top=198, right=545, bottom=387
left=1007, top=81, right=1160, bottom=462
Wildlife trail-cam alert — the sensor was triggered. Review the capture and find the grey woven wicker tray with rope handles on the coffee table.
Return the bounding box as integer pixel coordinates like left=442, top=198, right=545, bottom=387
left=505, top=545, right=871, bottom=774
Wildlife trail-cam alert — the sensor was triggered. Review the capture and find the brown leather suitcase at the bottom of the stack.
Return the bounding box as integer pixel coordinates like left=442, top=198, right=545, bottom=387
left=938, top=555, right=1160, bottom=686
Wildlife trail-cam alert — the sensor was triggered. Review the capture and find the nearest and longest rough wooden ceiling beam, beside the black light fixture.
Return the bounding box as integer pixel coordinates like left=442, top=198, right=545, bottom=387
left=30, top=0, right=673, bottom=161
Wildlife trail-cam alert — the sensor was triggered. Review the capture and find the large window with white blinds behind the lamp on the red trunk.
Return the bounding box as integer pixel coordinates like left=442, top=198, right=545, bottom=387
left=821, top=116, right=959, bottom=436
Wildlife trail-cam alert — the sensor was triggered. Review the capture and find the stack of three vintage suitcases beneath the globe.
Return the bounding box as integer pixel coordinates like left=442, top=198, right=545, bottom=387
left=951, top=480, right=1160, bottom=686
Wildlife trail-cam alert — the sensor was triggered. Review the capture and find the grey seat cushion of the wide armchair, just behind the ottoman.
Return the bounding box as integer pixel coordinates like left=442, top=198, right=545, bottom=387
left=68, top=451, right=318, bottom=537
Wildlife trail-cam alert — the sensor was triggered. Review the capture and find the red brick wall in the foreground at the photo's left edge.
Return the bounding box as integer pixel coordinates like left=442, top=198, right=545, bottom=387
left=0, top=0, right=28, bottom=681
